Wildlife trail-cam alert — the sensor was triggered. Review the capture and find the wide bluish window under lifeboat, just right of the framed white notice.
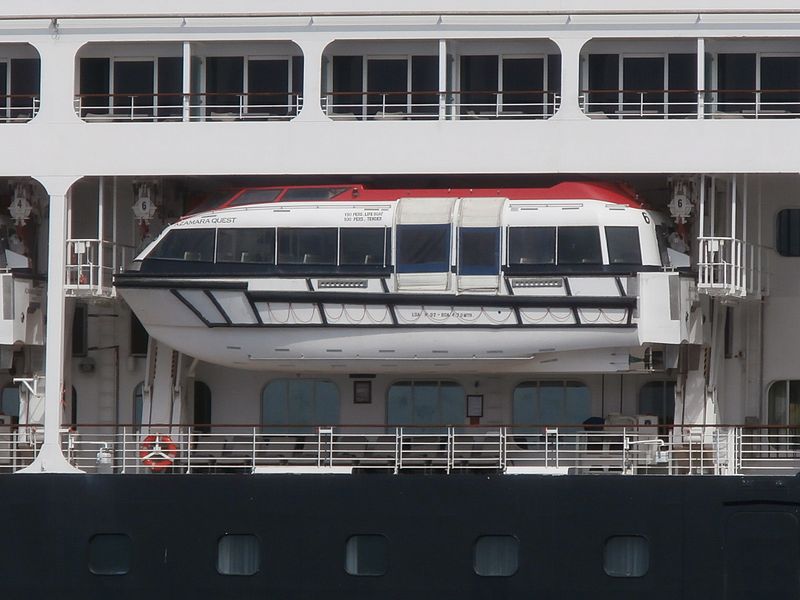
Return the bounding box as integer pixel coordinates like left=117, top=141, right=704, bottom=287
left=513, top=381, right=592, bottom=425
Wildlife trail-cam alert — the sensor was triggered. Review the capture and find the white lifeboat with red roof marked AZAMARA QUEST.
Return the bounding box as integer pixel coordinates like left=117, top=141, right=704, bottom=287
left=115, top=183, right=688, bottom=372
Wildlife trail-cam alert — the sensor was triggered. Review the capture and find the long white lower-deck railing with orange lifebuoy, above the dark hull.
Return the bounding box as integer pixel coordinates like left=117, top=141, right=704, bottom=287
left=0, top=425, right=788, bottom=475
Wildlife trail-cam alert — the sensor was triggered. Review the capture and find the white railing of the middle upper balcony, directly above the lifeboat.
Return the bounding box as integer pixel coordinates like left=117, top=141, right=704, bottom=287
left=321, top=90, right=560, bottom=121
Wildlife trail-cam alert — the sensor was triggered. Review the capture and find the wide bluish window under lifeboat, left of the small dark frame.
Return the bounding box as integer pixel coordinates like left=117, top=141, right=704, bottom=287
left=261, top=379, right=339, bottom=432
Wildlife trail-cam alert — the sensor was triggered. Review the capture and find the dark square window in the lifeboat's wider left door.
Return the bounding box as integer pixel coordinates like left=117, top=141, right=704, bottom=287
left=397, top=223, right=450, bottom=273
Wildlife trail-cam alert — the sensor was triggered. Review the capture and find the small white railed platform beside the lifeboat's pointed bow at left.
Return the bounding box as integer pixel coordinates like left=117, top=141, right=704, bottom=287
left=64, top=239, right=134, bottom=297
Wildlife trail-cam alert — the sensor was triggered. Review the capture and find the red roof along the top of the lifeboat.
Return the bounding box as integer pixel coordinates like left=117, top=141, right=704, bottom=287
left=212, top=182, right=642, bottom=210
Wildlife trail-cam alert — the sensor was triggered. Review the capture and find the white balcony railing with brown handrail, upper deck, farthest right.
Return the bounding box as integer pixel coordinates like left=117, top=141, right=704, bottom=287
left=579, top=89, right=800, bottom=119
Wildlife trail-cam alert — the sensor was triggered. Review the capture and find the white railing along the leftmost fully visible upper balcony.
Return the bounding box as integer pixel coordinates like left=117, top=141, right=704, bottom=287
left=75, top=92, right=303, bottom=122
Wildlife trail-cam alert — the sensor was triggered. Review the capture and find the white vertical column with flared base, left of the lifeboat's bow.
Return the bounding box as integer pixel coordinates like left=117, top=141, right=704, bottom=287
left=20, top=181, right=78, bottom=473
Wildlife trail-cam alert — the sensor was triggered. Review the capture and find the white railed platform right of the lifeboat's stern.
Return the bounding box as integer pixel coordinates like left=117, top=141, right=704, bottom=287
left=697, top=237, right=769, bottom=300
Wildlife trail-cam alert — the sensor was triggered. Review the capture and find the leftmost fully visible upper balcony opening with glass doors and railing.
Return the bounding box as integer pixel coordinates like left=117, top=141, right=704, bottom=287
left=74, top=42, right=303, bottom=122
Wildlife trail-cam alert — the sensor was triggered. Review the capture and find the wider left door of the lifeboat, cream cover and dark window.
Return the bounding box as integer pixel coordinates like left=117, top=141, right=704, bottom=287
left=394, top=198, right=456, bottom=292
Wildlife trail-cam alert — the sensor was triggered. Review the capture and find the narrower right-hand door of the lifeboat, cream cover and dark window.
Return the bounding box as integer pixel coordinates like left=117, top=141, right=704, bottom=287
left=456, top=198, right=508, bottom=293
